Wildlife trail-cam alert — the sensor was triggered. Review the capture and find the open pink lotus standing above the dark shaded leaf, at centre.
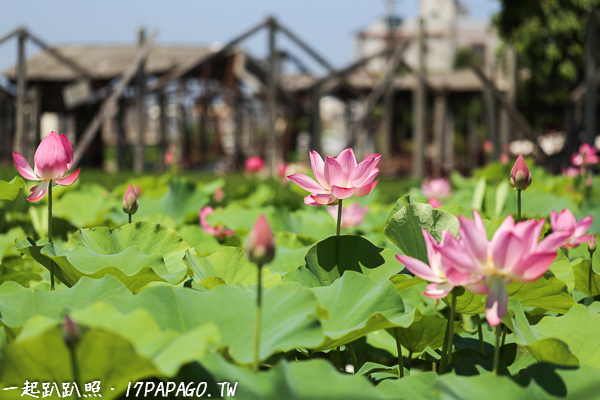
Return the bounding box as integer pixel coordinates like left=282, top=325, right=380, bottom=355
left=288, top=149, right=381, bottom=206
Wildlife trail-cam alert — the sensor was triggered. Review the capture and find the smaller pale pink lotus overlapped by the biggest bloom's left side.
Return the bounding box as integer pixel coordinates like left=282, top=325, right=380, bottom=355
left=396, top=229, right=481, bottom=299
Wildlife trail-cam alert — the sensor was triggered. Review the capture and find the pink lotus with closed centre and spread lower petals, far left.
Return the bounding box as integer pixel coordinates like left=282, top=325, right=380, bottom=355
left=13, top=132, right=80, bottom=201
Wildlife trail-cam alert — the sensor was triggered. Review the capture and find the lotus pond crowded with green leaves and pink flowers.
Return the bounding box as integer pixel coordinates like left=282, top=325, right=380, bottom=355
left=0, top=151, right=600, bottom=400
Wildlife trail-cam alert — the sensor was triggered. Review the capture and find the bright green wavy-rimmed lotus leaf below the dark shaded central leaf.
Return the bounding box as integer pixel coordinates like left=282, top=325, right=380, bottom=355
left=311, top=271, right=415, bottom=351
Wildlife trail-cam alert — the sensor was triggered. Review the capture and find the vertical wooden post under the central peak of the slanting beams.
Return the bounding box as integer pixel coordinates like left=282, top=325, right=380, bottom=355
left=266, top=21, right=277, bottom=176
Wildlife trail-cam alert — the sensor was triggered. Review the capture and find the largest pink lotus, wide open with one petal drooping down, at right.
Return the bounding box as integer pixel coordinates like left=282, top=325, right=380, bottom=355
left=439, top=211, right=568, bottom=326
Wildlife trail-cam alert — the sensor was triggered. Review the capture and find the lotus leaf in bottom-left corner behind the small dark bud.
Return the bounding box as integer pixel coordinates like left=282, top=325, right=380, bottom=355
left=0, top=326, right=159, bottom=399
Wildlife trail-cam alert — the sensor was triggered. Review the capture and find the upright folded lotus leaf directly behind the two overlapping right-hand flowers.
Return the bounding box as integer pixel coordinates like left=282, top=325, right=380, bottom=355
left=383, top=203, right=460, bottom=262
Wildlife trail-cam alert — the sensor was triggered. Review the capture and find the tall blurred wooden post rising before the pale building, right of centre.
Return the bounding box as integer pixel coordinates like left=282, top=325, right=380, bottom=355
left=413, top=18, right=426, bottom=178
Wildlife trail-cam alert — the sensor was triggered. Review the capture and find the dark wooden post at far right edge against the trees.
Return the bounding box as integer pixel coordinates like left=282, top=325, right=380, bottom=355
left=585, top=6, right=598, bottom=145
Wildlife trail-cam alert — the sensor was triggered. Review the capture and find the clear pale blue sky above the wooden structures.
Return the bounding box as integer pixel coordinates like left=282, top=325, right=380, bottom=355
left=0, top=0, right=500, bottom=76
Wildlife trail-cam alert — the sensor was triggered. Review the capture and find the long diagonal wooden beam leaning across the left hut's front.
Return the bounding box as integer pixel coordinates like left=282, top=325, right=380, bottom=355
left=73, top=31, right=157, bottom=166
